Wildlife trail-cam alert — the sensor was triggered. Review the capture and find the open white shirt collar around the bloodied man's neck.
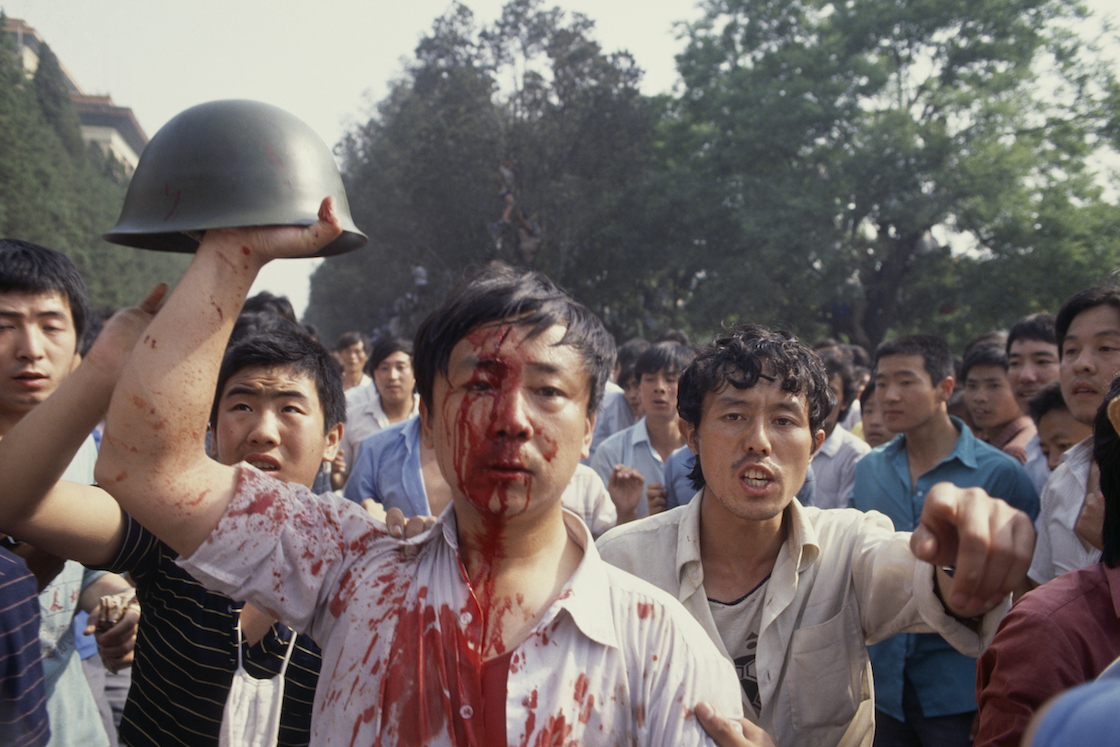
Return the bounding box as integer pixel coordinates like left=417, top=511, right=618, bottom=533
left=432, top=504, right=619, bottom=648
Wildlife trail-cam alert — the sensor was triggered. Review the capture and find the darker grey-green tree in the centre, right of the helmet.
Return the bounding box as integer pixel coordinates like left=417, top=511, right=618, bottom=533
left=307, top=0, right=652, bottom=339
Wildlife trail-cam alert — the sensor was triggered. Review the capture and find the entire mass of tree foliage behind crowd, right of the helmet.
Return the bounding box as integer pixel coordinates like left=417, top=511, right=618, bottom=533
left=308, top=0, right=1120, bottom=347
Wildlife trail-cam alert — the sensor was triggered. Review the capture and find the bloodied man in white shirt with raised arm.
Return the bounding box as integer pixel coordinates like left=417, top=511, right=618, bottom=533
left=97, top=200, right=741, bottom=745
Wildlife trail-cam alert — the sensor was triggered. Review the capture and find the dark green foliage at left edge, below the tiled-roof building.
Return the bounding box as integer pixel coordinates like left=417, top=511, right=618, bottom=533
left=0, top=17, right=187, bottom=309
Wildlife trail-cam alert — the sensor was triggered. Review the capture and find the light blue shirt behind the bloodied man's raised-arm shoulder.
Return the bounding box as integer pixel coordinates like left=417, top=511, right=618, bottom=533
left=343, top=418, right=431, bottom=519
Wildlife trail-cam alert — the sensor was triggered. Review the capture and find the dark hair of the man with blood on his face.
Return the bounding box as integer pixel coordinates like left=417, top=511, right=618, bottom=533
left=412, top=265, right=615, bottom=415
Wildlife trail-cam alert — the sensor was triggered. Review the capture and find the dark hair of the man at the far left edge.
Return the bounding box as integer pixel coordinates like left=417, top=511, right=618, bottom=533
left=0, top=239, right=90, bottom=349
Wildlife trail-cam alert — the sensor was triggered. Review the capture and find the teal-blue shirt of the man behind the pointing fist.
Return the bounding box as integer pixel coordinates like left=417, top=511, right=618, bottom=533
left=850, top=418, right=1038, bottom=721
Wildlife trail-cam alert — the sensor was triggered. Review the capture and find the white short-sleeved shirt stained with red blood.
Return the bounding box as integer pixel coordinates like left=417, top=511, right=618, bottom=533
left=179, top=465, right=743, bottom=747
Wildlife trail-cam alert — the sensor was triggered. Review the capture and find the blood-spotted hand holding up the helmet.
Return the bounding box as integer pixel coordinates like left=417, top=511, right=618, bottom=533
left=198, top=197, right=343, bottom=267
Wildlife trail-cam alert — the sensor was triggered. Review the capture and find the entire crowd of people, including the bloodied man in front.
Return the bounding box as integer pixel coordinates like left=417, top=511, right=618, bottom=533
left=0, top=200, right=1120, bottom=747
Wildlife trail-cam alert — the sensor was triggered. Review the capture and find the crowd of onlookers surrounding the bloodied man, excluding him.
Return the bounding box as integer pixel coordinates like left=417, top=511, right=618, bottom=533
left=0, top=229, right=1120, bottom=747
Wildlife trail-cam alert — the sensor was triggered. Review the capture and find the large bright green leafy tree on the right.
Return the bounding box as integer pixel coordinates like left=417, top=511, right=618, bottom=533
left=666, top=0, right=1120, bottom=346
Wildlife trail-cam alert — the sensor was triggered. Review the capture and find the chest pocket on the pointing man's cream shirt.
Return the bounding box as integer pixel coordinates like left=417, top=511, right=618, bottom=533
left=786, top=606, right=870, bottom=730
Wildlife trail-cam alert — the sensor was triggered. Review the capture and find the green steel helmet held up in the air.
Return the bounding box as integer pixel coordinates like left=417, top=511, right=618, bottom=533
left=103, top=100, right=367, bottom=256
